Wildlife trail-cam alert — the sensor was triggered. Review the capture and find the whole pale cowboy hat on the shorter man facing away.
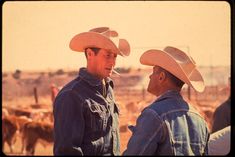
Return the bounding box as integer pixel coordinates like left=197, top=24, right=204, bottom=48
left=140, top=46, right=205, bottom=92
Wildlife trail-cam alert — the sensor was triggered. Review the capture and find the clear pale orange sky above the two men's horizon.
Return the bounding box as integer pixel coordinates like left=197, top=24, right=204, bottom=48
left=2, top=1, right=231, bottom=71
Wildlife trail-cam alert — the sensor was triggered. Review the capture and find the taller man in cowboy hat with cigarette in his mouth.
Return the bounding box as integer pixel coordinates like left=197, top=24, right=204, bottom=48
left=53, top=27, right=130, bottom=155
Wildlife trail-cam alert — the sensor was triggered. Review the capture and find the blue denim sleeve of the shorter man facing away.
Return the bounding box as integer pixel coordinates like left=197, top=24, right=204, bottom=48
left=123, top=109, right=164, bottom=155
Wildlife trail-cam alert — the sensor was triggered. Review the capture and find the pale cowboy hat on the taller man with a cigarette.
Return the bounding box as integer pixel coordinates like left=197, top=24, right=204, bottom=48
left=69, top=27, right=130, bottom=56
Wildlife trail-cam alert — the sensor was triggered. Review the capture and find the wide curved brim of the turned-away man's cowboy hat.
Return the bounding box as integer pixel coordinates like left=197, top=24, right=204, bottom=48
left=140, top=49, right=205, bottom=92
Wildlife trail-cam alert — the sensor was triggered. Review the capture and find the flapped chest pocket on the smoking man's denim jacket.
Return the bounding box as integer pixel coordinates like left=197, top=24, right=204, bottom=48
left=86, top=102, right=108, bottom=132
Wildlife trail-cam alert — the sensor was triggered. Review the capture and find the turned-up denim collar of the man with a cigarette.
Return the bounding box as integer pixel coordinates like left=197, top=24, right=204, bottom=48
left=78, top=67, right=112, bottom=86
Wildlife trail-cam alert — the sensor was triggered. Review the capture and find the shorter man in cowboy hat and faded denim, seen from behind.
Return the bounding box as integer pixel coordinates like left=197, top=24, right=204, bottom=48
left=124, top=46, right=209, bottom=155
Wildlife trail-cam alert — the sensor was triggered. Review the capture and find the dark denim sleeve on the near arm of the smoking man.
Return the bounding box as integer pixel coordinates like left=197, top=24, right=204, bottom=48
left=53, top=90, right=85, bottom=155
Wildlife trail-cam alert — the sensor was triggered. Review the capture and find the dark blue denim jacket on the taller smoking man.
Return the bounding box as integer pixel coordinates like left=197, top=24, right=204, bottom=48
left=53, top=68, right=120, bottom=155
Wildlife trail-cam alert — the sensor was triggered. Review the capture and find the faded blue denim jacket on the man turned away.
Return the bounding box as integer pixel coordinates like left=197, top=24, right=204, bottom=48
left=123, top=91, right=209, bottom=155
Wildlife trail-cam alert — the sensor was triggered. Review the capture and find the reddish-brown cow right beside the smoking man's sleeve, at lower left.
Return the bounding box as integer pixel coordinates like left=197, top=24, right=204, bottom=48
left=22, top=121, right=54, bottom=155
